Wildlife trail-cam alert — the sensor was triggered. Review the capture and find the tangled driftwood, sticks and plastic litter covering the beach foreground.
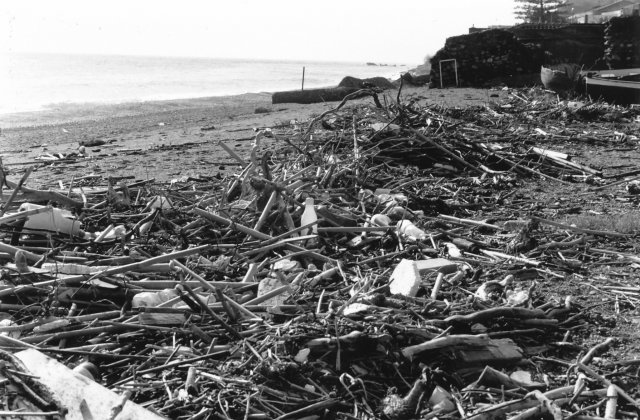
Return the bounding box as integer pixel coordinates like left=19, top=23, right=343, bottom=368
left=0, top=85, right=640, bottom=420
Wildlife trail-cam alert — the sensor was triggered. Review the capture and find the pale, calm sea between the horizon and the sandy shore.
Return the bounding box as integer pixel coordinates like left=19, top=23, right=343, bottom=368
left=0, top=53, right=408, bottom=114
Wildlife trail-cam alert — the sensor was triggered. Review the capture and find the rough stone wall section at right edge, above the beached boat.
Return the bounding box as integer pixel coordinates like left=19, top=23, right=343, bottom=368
left=604, top=16, right=640, bottom=69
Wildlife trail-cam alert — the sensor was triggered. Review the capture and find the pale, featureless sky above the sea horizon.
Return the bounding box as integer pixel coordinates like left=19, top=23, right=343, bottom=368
left=0, top=0, right=515, bottom=65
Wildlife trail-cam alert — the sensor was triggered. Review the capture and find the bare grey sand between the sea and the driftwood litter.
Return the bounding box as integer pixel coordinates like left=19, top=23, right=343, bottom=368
left=0, top=87, right=506, bottom=189
